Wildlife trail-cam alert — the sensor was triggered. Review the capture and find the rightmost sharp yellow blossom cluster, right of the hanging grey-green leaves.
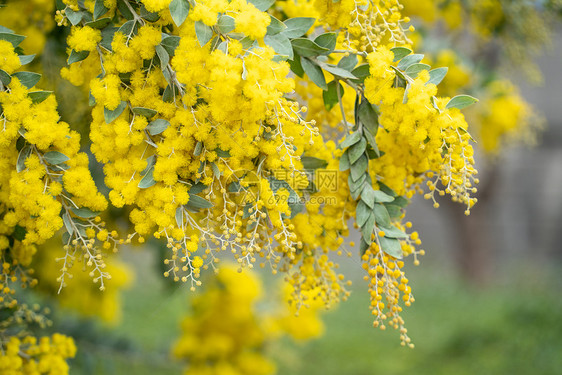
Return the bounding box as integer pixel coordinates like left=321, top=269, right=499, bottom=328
left=365, top=47, right=476, bottom=210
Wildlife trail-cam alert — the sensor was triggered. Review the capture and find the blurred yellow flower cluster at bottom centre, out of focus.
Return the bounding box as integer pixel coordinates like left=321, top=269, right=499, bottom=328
left=173, top=266, right=323, bottom=375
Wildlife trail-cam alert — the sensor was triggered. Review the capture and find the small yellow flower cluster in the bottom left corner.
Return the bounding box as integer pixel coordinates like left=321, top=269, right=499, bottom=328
left=0, top=333, right=76, bottom=375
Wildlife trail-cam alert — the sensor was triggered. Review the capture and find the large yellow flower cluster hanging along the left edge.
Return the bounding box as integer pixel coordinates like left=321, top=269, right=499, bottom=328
left=0, top=36, right=116, bottom=303
